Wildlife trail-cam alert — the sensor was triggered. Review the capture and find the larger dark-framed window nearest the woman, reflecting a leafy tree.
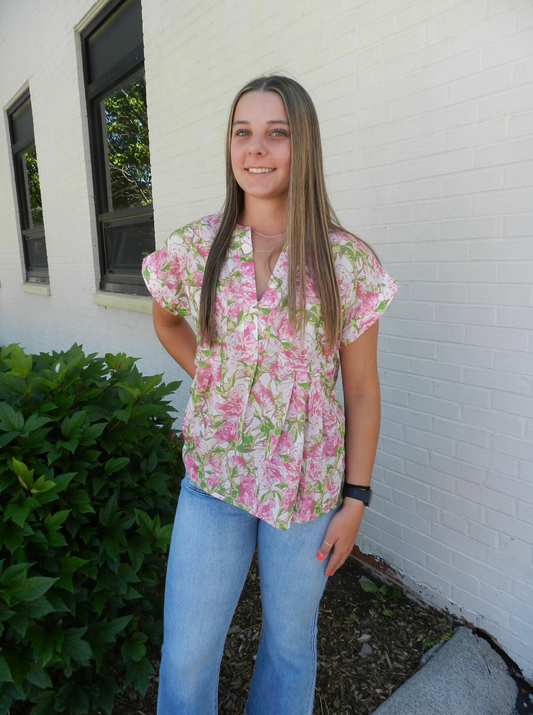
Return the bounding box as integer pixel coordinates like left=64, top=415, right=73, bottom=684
left=81, top=0, right=155, bottom=295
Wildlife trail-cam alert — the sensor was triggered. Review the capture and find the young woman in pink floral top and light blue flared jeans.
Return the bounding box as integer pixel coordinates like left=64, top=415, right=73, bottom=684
left=143, top=76, right=396, bottom=715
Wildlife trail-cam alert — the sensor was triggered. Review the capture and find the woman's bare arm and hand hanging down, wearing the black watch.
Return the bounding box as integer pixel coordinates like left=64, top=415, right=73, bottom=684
left=318, top=321, right=381, bottom=576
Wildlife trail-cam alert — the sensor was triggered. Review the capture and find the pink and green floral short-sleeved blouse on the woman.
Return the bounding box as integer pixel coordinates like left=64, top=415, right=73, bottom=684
left=143, top=215, right=397, bottom=529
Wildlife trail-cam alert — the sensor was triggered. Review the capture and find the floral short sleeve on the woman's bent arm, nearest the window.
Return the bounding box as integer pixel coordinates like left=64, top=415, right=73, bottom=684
left=142, top=234, right=190, bottom=316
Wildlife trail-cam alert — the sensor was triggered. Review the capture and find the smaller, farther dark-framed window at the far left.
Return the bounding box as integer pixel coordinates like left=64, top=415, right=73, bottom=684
left=8, top=92, right=49, bottom=283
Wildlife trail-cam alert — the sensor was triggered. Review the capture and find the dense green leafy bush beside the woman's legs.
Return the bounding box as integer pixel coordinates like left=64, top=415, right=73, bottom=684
left=0, top=345, right=184, bottom=715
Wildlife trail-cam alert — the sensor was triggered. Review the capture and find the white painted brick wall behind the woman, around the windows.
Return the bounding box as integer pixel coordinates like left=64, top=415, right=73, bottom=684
left=0, top=0, right=533, bottom=677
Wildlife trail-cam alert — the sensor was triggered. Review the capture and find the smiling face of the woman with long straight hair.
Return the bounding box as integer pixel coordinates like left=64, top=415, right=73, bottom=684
left=231, top=92, right=291, bottom=200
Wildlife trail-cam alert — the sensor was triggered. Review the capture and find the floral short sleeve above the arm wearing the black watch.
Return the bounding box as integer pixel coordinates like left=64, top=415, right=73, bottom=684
left=335, top=236, right=398, bottom=348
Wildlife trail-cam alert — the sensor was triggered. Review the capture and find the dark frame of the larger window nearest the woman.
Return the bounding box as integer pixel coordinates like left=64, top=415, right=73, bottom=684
left=80, top=0, right=155, bottom=295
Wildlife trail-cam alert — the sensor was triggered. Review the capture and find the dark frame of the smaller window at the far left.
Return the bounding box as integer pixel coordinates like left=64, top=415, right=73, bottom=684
left=7, top=89, right=50, bottom=285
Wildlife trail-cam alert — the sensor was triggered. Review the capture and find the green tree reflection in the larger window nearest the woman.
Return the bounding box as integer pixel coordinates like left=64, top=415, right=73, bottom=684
left=102, top=77, right=152, bottom=211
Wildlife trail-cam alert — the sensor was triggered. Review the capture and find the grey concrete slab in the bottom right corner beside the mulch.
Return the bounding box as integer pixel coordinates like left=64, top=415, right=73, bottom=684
left=374, top=627, right=518, bottom=715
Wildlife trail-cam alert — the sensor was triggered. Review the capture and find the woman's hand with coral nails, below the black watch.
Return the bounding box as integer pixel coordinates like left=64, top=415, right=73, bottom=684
left=317, top=498, right=365, bottom=576
